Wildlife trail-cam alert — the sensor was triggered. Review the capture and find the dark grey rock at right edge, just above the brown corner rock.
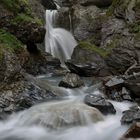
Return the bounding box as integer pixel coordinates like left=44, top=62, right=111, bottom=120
left=121, top=107, right=140, bottom=124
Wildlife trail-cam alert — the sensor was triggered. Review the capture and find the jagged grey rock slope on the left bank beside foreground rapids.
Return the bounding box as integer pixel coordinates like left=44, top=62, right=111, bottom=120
left=0, top=74, right=58, bottom=113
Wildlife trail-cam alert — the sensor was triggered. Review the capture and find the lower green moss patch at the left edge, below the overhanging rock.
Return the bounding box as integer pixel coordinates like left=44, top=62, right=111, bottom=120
left=0, top=29, right=22, bottom=51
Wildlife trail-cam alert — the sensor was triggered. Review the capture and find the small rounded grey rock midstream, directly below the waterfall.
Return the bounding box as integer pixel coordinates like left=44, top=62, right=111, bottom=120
left=59, top=73, right=84, bottom=88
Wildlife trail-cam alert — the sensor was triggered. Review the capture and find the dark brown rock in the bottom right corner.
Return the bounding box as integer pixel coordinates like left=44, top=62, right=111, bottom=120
left=123, top=122, right=140, bottom=139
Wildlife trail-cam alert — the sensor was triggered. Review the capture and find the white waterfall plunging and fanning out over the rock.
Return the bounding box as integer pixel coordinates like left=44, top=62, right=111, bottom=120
left=45, top=10, right=77, bottom=66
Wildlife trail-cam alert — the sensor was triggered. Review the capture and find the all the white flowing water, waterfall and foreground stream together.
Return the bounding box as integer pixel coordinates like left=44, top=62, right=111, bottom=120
left=0, top=3, right=131, bottom=140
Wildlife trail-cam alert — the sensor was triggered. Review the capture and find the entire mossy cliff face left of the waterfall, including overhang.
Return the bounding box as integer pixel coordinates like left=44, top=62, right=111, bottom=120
left=0, top=0, right=45, bottom=83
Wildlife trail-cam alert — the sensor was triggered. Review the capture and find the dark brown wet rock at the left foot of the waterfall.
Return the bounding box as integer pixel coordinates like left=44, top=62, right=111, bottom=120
left=24, top=52, right=60, bottom=76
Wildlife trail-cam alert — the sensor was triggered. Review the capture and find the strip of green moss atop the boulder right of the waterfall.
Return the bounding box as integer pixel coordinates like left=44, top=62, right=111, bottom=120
left=78, top=41, right=109, bottom=57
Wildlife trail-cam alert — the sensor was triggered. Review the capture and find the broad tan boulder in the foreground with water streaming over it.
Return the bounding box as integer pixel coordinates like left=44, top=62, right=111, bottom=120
left=17, top=101, right=103, bottom=129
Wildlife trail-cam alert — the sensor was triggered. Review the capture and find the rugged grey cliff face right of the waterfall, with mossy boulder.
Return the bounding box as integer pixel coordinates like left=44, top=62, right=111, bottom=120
left=58, top=0, right=140, bottom=74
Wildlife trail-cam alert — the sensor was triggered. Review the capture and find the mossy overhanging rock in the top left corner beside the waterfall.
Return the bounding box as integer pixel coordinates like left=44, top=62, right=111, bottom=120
left=0, top=0, right=45, bottom=44
